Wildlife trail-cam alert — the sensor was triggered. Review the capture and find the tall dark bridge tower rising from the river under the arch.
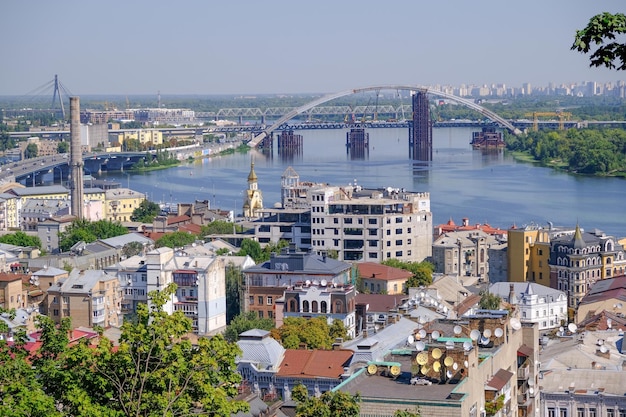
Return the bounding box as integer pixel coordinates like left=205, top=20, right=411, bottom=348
left=409, top=91, right=433, bottom=161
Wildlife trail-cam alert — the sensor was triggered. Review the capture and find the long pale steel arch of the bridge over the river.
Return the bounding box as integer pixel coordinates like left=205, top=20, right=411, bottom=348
left=248, top=85, right=522, bottom=147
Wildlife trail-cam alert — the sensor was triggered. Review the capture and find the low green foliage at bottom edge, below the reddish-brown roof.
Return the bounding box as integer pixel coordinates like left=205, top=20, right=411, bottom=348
left=292, top=384, right=361, bottom=417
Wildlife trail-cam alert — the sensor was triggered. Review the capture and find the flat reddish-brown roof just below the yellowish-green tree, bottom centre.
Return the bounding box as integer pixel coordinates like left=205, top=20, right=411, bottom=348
left=277, top=349, right=353, bottom=378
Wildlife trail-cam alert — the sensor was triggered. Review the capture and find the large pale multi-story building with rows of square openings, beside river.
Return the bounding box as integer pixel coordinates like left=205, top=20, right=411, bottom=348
left=309, top=185, right=433, bottom=262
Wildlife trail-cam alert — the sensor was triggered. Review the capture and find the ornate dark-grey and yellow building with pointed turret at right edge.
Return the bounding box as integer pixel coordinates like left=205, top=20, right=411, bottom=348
left=549, top=225, right=625, bottom=309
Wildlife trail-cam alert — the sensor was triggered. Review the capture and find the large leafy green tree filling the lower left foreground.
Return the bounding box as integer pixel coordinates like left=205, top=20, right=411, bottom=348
left=30, top=284, right=248, bottom=417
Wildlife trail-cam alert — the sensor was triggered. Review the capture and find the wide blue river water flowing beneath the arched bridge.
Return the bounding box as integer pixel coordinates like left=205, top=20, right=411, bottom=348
left=103, top=128, right=626, bottom=237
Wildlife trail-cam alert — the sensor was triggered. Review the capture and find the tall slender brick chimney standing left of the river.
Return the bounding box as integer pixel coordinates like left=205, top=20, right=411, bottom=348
left=69, top=97, right=84, bottom=219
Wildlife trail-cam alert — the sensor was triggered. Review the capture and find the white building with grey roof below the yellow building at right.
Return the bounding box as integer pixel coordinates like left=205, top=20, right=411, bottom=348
left=489, top=282, right=568, bottom=331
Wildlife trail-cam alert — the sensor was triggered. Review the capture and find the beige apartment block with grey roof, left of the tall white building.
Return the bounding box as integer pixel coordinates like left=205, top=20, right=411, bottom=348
left=45, top=269, right=122, bottom=328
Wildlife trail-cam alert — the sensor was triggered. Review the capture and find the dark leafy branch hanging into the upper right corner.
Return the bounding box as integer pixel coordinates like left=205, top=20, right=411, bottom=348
left=571, top=12, right=626, bottom=71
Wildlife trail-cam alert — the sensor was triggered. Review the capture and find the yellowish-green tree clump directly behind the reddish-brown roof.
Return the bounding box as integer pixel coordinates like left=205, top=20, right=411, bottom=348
left=272, top=316, right=347, bottom=349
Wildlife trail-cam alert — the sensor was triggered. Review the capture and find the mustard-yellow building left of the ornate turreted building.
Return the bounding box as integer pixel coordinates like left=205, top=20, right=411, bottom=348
left=507, top=225, right=550, bottom=287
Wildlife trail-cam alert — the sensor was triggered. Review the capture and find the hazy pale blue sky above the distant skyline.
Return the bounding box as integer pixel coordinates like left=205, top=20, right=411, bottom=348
left=0, top=0, right=626, bottom=95
